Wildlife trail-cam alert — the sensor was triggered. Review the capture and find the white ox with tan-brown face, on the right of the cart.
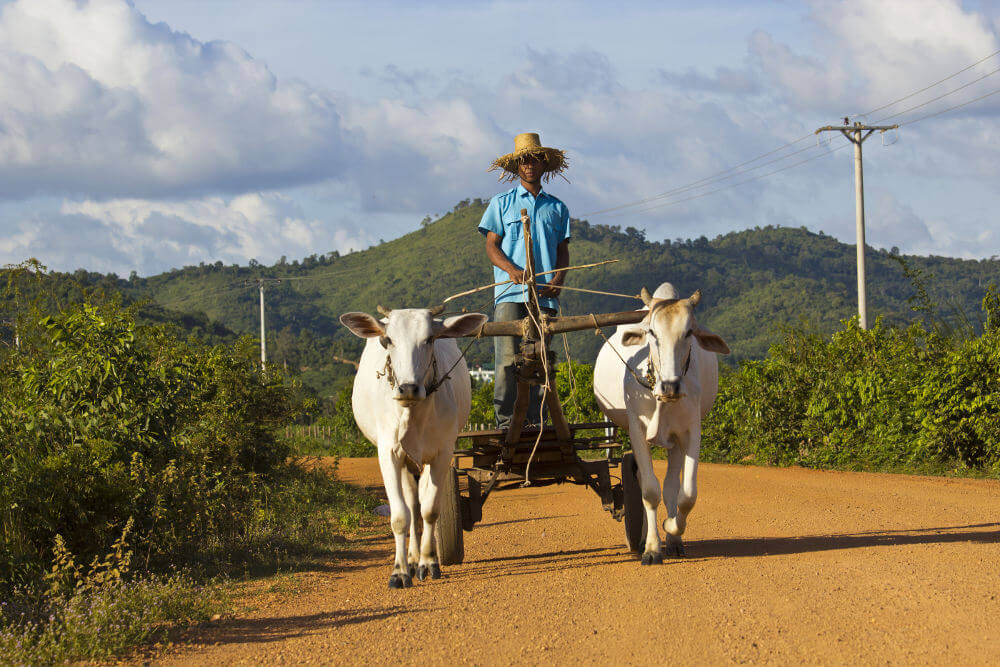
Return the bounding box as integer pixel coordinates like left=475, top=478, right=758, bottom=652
left=594, top=283, right=729, bottom=565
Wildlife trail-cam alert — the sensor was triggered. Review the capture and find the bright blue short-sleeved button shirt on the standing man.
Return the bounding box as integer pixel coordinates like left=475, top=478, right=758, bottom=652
left=479, top=184, right=569, bottom=308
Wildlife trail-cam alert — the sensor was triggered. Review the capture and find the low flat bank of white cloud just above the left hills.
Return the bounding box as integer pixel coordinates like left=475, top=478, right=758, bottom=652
left=0, top=193, right=375, bottom=274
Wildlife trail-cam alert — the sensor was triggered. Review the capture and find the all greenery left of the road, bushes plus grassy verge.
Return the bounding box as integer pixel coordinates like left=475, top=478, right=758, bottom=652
left=0, top=264, right=376, bottom=664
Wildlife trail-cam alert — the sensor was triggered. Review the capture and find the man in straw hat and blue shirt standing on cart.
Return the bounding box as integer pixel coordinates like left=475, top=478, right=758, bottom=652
left=479, top=132, right=569, bottom=429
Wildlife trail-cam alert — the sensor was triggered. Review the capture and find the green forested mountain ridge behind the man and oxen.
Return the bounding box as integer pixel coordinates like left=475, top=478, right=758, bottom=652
left=3, top=200, right=1000, bottom=396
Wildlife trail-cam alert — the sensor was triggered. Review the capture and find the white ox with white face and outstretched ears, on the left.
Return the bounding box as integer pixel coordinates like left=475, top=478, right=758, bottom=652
left=340, top=309, right=487, bottom=588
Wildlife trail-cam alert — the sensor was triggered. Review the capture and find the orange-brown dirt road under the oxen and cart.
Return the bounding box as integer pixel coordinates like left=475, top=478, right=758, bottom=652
left=167, top=459, right=1000, bottom=665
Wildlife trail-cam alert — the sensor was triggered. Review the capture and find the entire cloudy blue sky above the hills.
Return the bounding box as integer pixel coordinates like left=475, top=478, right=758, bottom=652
left=0, top=0, right=1000, bottom=275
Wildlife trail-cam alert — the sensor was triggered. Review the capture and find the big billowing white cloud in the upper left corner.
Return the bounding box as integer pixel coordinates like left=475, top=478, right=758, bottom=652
left=0, top=0, right=352, bottom=198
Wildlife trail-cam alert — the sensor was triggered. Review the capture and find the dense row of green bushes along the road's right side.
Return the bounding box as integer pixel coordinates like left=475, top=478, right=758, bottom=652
left=702, top=293, right=1000, bottom=475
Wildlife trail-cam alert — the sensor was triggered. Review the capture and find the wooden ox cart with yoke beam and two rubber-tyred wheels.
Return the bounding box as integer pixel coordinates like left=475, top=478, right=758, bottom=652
left=436, top=209, right=646, bottom=565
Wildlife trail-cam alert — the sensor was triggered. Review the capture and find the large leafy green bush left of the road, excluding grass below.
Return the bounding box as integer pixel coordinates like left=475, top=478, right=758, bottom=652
left=0, top=304, right=291, bottom=582
